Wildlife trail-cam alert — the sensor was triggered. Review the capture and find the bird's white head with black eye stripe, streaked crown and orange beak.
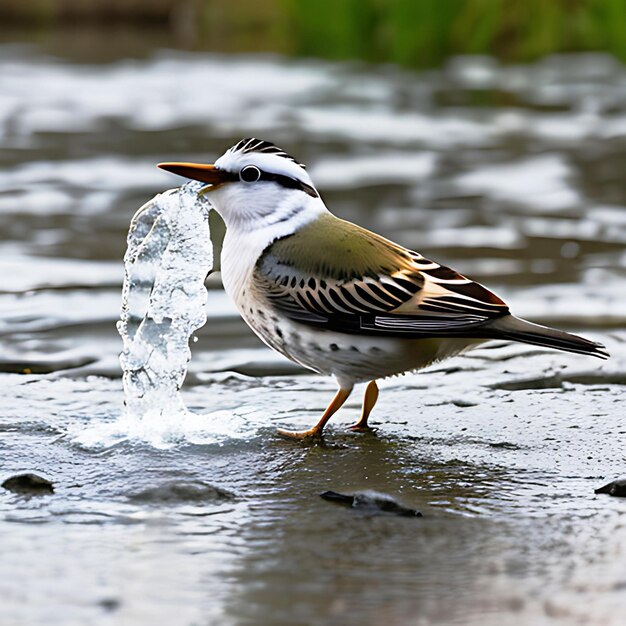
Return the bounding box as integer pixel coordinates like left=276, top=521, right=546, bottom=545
left=159, top=138, right=321, bottom=228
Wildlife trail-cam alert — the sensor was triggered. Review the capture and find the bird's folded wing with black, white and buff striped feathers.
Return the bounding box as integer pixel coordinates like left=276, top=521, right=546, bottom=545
left=254, top=250, right=509, bottom=337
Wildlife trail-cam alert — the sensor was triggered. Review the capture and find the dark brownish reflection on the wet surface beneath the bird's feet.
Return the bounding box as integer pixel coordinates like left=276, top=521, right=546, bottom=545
left=224, top=437, right=498, bottom=624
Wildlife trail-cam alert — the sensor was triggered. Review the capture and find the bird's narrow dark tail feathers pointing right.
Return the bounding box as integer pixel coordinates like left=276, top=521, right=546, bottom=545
left=485, top=315, right=609, bottom=359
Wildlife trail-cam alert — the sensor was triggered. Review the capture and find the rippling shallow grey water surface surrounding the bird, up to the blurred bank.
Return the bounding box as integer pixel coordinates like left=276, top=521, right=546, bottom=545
left=0, top=46, right=626, bottom=626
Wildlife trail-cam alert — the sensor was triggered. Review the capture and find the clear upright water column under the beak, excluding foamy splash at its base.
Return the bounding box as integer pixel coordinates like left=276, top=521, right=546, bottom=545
left=117, top=183, right=213, bottom=420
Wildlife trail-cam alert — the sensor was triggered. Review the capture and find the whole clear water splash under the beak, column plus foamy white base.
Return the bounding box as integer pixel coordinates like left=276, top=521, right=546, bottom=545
left=75, top=182, right=259, bottom=448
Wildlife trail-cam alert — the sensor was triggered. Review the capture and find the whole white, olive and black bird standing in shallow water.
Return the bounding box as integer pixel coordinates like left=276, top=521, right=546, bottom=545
left=158, top=137, right=609, bottom=440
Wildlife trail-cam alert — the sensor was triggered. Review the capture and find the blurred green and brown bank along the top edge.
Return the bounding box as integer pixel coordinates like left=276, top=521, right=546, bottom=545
left=0, top=0, right=626, bottom=67
